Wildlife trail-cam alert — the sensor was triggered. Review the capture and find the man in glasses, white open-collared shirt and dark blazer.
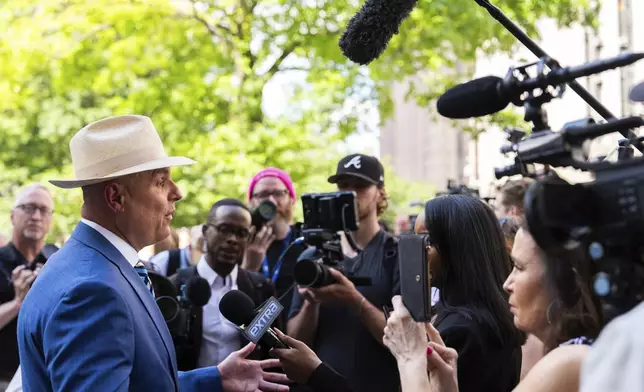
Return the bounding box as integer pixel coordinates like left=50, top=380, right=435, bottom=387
left=170, top=199, right=274, bottom=370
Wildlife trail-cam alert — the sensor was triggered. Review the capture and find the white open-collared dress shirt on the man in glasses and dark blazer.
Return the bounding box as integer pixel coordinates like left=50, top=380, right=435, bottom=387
left=197, top=255, right=241, bottom=368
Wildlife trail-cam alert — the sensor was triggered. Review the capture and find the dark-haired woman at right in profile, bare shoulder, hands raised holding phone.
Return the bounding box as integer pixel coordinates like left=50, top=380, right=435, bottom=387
left=385, top=204, right=603, bottom=392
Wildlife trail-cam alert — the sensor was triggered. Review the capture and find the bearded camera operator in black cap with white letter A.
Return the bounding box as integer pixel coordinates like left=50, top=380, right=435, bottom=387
left=288, top=154, right=400, bottom=391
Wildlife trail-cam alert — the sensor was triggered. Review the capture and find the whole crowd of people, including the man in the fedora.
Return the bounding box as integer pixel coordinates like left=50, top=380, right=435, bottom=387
left=0, top=115, right=640, bottom=392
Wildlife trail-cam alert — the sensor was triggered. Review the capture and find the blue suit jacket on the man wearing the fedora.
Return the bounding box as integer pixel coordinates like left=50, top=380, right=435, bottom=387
left=18, top=223, right=222, bottom=392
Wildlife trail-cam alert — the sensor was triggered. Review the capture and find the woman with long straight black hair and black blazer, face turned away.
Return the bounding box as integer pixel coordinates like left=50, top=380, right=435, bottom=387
left=388, top=195, right=524, bottom=392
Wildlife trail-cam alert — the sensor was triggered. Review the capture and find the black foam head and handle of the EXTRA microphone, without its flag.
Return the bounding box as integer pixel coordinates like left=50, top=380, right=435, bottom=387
left=219, top=290, right=290, bottom=348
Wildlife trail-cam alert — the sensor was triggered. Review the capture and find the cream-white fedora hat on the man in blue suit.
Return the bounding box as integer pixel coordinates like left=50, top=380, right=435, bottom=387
left=49, top=115, right=195, bottom=189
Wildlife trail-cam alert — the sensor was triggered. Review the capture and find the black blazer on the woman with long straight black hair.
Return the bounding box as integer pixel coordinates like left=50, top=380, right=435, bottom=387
left=434, top=304, right=521, bottom=392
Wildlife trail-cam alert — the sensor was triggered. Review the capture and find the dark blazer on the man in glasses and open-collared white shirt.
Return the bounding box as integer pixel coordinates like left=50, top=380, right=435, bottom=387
left=170, top=265, right=281, bottom=370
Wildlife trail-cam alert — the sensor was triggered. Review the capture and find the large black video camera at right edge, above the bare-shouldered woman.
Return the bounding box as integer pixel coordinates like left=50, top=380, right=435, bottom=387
left=488, top=55, right=644, bottom=320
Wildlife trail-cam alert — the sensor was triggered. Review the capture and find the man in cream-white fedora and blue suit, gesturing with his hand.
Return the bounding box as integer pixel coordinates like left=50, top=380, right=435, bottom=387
left=18, top=115, right=288, bottom=392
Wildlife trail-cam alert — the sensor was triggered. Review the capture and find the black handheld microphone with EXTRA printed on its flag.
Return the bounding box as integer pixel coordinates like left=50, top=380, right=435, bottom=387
left=219, top=290, right=290, bottom=348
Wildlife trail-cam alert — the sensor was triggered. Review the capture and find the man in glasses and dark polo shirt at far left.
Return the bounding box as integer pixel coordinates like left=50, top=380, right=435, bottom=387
left=0, top=184, right=55, bottom=390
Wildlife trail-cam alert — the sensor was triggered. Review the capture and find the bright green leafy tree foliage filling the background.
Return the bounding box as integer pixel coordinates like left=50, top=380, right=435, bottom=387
left=0, top=0, right=586, bottom=239
